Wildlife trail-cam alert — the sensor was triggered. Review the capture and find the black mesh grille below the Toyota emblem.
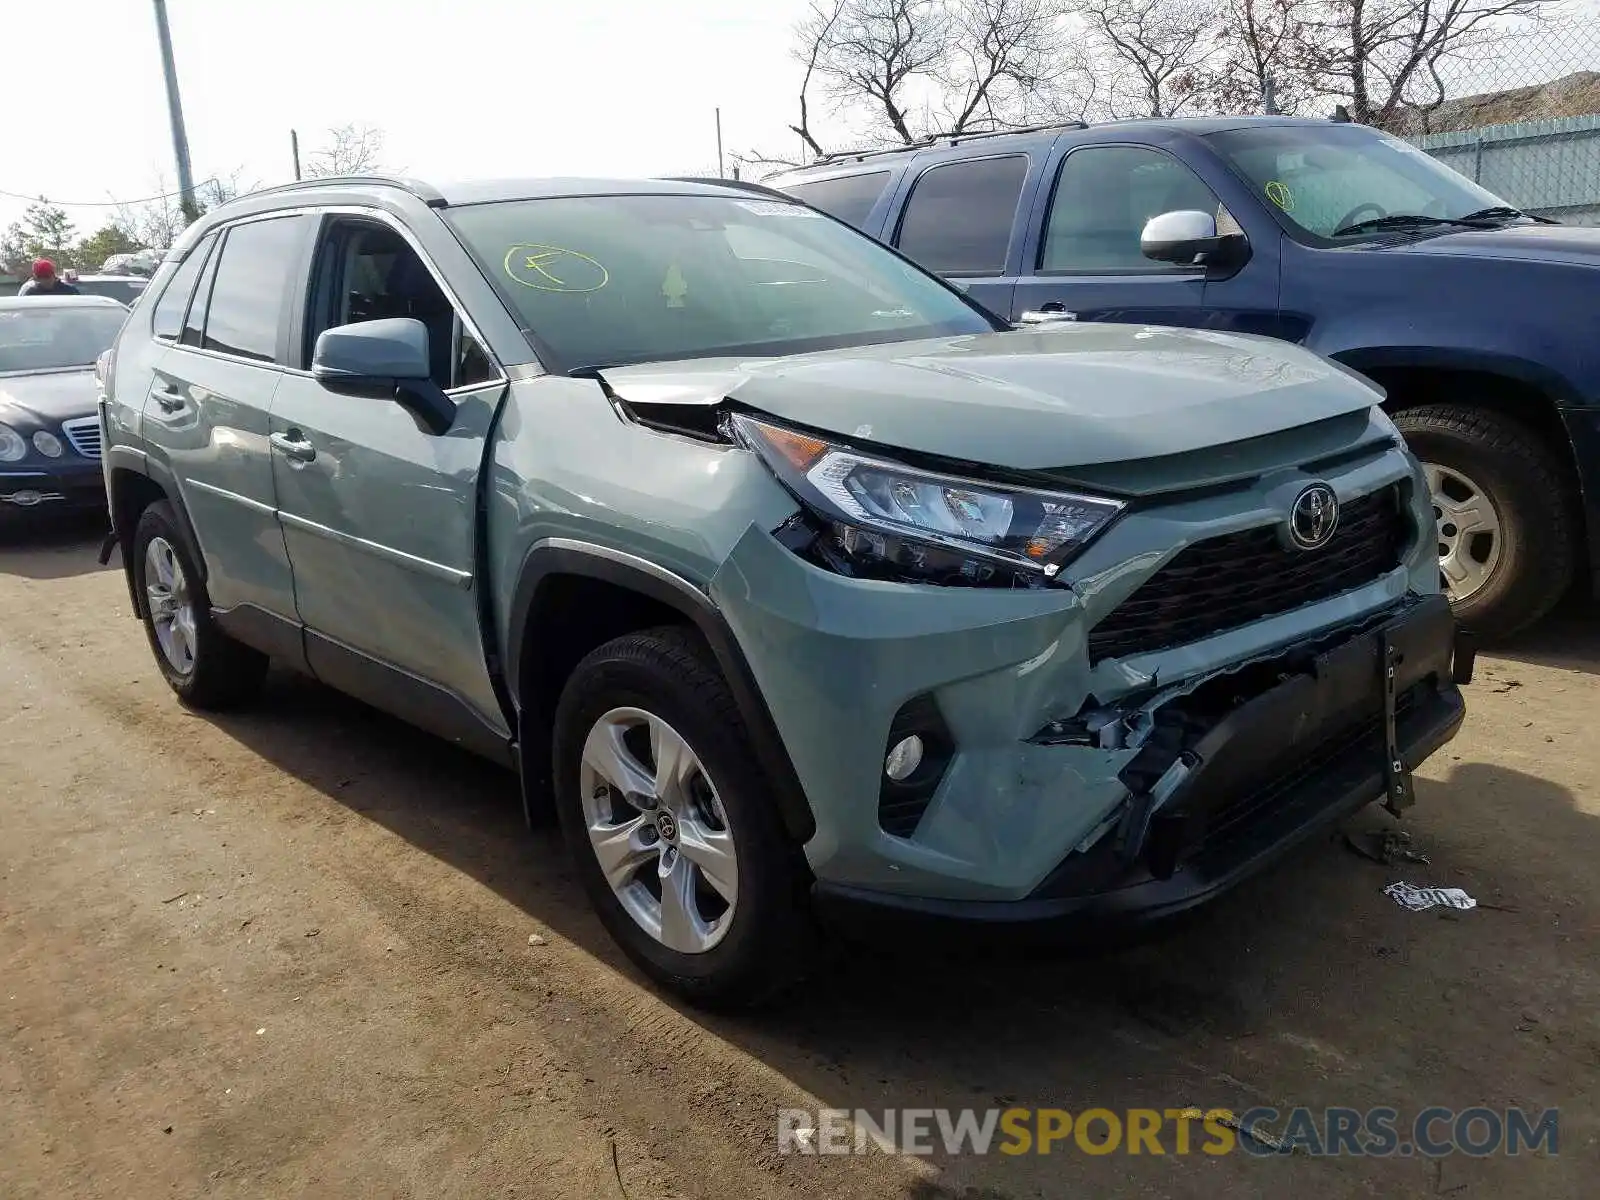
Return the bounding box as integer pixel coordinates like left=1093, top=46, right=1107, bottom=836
left=1090, top=486, right=1405, bottom=662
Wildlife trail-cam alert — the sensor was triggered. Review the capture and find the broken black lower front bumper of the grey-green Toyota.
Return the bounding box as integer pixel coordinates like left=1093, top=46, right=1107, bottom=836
left=816, top=595, right=1472, bottom=939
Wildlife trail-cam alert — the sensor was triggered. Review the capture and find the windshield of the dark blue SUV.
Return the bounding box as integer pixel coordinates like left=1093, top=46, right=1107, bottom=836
left=1208, top=125, right=1506, bottom=242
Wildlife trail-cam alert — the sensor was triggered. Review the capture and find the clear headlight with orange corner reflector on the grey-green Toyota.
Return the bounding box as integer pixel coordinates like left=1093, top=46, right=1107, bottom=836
left=733, top=414, right=1125, bottom=587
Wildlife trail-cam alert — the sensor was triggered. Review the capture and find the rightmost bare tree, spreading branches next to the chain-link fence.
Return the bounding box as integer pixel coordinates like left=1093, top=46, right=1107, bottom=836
left=1302, top=0, right=1555, bottom=126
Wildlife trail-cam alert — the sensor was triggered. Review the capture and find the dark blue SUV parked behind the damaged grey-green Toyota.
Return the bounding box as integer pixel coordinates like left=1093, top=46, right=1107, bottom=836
left=770, top=117, right=1600, bottom=637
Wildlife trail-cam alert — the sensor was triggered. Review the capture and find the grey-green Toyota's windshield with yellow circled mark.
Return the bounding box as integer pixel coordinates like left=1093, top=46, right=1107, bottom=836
left=446, top=195, right=998, bottom=371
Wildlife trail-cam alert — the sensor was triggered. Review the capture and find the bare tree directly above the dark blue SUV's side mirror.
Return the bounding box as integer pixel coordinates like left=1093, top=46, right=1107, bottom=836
left=1074, top=0, right=1216, bottom=117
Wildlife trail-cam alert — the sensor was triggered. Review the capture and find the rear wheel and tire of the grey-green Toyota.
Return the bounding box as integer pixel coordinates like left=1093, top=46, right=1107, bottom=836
left=133, top=501, right=267, bottom=709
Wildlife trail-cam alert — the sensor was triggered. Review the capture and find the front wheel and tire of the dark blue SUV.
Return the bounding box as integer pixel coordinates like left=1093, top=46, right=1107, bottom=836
left=1395, top=405, right=1578, bottom=640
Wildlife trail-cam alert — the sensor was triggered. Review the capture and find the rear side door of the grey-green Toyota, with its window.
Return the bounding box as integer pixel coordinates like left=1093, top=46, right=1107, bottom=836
left=141, top=214, right=312, bottom=659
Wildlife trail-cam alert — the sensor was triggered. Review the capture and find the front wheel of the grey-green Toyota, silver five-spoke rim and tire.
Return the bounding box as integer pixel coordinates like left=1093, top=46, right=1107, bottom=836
left=554, top=627, right=816, bottom=1008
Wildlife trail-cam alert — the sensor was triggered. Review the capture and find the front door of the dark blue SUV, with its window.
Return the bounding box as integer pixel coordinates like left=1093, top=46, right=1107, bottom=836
left=1011, top=144, right=1277, bottom=331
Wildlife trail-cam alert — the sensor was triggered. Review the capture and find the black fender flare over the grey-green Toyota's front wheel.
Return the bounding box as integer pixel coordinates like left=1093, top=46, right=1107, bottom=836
left=504, top=538, right=816, bottom=845
